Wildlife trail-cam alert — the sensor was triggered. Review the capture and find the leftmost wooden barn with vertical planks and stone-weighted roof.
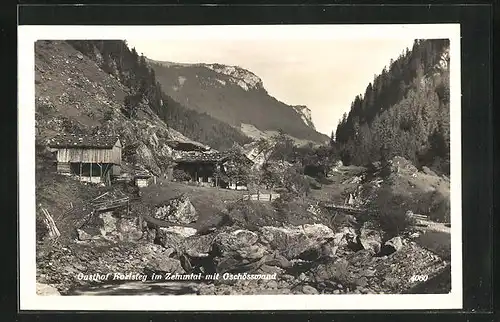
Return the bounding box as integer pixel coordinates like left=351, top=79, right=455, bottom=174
left=49, top=135, right=122, bottom=184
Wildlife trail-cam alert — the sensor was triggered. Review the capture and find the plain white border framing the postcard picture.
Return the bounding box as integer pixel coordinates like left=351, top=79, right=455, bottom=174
left=18, top=24, right=463, bottom=311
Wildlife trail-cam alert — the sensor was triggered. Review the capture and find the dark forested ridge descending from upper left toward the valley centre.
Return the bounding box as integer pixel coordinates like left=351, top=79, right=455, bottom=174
left=69, top=40, right=250, bottom=149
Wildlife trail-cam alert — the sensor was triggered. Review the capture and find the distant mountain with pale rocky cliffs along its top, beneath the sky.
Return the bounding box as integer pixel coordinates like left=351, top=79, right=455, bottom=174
left=149, top=60, right=328, bottom=143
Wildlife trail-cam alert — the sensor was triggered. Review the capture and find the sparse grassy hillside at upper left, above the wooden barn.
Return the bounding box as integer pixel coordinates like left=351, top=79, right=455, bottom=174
left=35, top=41, right=127, bottom=136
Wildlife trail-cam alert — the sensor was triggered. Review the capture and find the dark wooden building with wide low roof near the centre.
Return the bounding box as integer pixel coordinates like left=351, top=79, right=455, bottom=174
left=173, top=152, right=253, bottom=189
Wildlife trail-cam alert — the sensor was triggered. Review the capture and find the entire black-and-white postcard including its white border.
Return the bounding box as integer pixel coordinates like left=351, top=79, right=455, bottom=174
left=19, top=24, right=462, bottom=310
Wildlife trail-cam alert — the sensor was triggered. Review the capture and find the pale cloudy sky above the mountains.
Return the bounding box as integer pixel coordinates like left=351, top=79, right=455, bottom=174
left=127, top=36, right=413, bottom=135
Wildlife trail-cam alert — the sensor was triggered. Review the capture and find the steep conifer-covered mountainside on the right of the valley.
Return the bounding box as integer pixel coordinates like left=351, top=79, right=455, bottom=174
left=335, top=39, right=450, bottom=174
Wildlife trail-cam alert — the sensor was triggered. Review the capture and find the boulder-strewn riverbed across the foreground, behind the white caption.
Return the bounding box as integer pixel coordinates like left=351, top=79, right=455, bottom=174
left=37, top=199, right=449, bottom=295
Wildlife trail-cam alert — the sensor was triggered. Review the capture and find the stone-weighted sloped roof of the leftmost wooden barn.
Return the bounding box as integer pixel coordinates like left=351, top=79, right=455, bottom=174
left=48, top=134, right=119, bottom=149
